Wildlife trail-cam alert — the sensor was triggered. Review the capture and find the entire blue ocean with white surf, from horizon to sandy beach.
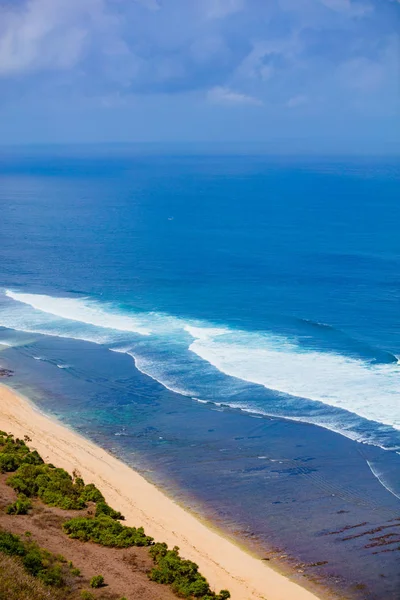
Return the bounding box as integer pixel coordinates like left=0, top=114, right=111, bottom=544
left=0, top=146, right=400, bottom=600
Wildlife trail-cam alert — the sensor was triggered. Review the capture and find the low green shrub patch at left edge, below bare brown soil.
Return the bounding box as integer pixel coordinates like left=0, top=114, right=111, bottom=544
left=0, top=530, right=79, bottom=588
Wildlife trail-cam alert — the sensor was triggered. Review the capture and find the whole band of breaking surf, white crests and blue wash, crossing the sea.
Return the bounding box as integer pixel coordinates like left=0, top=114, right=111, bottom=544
left=0, top=290, right=400, bottom=448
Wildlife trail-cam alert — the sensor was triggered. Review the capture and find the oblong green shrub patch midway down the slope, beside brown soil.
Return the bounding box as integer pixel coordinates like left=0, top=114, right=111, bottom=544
left=63, top=514, right=153, bottom=548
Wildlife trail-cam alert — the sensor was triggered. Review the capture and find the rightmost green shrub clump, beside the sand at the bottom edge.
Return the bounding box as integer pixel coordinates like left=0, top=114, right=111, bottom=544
left=149, top=543, right=231, bottom=600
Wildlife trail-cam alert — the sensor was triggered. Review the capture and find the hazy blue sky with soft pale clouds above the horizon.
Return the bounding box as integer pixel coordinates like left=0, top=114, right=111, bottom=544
left=0, top=0, right=400, bottom=154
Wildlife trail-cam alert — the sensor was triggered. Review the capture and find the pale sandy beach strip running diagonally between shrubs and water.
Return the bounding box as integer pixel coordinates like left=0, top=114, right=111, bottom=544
left=0, top=383, right=322, bottom=600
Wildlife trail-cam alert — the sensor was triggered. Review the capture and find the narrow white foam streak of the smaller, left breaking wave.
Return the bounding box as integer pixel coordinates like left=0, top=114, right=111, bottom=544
left=6, top=290, right=150, bottom=335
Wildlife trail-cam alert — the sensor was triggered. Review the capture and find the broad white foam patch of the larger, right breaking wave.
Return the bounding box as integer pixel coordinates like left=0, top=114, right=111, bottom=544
left=190, top=328, right=400, bottom=430
